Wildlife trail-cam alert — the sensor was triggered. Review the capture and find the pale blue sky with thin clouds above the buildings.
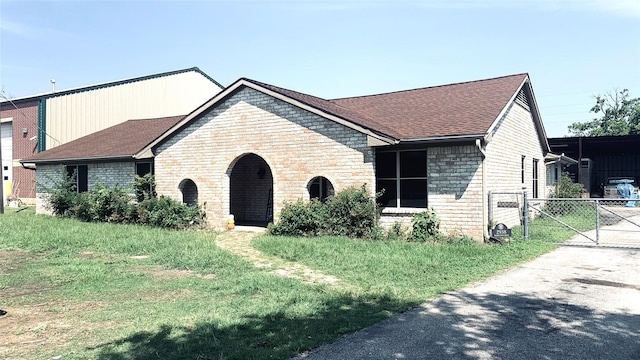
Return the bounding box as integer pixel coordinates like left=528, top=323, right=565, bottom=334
left=0, top=0, right=640, bottom=137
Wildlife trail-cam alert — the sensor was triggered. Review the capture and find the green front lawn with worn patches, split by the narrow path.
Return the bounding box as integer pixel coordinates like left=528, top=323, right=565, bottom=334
left=0, top=209, right=554, bottom=359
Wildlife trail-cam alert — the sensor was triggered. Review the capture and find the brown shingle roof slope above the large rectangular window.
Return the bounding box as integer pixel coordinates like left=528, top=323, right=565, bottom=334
left=330, top=74, right=528, bottom=140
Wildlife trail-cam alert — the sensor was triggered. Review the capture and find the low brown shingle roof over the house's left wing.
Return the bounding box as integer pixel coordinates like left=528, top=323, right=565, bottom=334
left=22, top=115, right=184, bottom=163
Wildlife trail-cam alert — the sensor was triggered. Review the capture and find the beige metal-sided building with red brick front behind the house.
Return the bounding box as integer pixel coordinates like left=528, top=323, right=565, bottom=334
left=0, top=67, right=222, bottom=203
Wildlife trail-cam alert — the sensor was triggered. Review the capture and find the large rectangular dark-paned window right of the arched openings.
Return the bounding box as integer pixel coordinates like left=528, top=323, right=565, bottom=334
left=376, top=150, right=427, bottom=208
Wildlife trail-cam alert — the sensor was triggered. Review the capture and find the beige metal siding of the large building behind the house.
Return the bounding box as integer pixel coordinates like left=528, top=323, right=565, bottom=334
left=46, top=71, right=221, bottom=149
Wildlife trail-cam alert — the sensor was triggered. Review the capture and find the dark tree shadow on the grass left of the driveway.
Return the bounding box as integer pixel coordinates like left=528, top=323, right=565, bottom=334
left=90, top=295, right=416, bottom=360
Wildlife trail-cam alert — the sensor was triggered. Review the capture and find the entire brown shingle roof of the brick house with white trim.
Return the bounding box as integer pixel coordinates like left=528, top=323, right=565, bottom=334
left=22, top=74, right=548, bottom=162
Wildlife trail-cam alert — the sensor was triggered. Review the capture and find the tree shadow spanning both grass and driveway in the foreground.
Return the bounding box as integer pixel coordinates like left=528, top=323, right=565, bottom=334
left=89, top=292, right=640, bottom=360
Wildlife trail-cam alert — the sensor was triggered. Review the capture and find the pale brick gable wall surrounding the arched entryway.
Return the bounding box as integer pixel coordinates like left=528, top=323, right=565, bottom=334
left=155, top=88, right=375, bottom=226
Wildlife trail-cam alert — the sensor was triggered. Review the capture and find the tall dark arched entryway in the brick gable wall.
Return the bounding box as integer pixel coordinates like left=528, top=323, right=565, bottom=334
left=229, top=154, right=273, bottom=226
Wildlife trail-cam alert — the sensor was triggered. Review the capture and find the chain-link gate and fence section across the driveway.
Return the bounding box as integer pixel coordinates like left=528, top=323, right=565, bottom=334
left=489, top=192, right=640, bottom=247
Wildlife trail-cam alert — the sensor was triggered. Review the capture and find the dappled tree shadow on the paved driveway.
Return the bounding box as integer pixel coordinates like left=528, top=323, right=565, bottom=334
left=298, top=292, right=640, bottom=360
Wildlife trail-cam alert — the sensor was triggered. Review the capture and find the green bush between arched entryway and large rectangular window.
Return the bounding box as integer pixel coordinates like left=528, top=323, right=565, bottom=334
left=268, top=186, right=377, bottom=238
